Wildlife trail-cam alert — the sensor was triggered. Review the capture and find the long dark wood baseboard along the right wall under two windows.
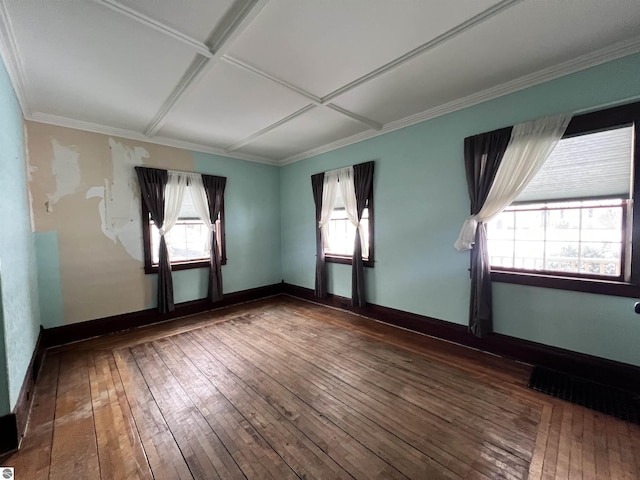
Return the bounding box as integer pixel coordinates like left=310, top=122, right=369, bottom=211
left=283, top=283, right=640, bottom=394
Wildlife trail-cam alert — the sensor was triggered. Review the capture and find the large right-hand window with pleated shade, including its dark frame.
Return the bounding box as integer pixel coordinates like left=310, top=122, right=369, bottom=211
left=487, top=104, right=640, bottom=296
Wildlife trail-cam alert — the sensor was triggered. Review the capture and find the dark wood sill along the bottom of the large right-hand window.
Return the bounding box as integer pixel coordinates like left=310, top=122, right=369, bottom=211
left=491, top=270, right=640, bottom=297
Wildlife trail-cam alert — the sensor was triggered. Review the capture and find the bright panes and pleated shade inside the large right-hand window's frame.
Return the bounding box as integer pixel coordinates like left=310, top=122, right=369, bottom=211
left=487, top=122, right=634, bottom=282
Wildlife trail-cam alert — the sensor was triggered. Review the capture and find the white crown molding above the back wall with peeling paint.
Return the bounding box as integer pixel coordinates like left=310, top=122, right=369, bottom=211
left=25, top=113, right=278, bottom=165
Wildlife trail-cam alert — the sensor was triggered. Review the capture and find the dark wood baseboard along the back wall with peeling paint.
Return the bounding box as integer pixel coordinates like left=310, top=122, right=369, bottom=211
left=43, top=283, right=282, bottom=348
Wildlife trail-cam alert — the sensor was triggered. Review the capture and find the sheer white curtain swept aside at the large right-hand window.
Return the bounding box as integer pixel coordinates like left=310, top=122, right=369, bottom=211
left=454, top=114, right=571, bottom=251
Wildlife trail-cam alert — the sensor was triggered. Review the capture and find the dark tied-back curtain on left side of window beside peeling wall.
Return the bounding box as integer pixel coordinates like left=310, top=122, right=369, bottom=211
left=136, top=167, right=175, bottom=313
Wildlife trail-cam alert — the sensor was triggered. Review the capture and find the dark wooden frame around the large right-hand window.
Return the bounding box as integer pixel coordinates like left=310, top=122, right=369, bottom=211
left=490, top=102, right=640, bottom=297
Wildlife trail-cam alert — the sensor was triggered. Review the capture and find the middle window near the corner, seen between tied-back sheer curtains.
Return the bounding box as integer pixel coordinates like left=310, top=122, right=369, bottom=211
left=324, top=183, right=373, bottom=267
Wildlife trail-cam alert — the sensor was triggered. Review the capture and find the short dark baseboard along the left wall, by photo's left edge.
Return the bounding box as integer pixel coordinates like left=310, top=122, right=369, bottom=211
left=0, top=327, right=44, bottom=456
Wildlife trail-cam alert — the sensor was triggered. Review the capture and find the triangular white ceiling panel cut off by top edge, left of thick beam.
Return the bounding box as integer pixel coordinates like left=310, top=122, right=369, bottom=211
left=114, top=0, right=239, bottom=43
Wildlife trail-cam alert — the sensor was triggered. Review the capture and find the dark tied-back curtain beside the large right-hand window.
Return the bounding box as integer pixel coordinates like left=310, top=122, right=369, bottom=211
left=464, top=127, right=512, bottom=337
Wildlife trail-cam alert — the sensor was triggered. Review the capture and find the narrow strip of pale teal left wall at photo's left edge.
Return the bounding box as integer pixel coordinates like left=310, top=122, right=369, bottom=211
left=0, top=62, right=40, bottom=415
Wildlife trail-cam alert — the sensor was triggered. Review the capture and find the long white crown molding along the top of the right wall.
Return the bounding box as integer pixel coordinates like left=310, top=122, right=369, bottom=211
left=278, top=36, right=640, bottom=166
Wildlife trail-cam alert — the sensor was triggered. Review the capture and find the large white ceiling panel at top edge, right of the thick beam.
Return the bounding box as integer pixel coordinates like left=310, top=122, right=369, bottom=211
left=229, top=0, right=497, bottom=97
